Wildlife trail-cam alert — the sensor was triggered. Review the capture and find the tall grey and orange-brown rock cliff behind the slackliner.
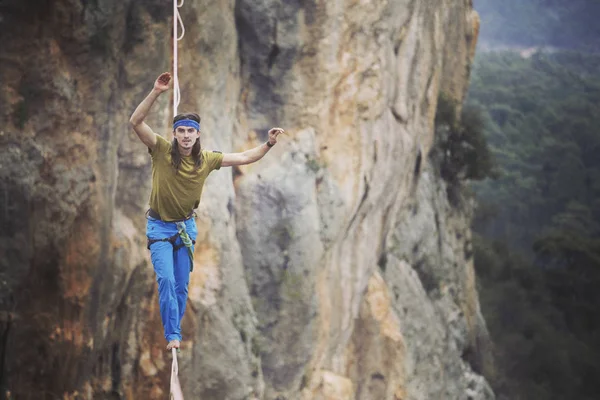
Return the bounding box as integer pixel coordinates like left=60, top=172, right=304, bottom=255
left=0, top=0, right=494, bottom=400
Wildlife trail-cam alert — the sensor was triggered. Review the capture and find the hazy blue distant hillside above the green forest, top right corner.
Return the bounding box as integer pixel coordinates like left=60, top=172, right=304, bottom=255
left=474, top=0, right=600, bottom=51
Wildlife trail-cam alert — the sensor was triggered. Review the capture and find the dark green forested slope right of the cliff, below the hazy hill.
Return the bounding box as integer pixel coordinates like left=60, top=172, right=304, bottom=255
left=468, top=50, right=600, bottom=400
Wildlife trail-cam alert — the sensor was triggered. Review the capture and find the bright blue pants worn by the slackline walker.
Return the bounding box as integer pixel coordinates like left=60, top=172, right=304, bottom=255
left=146, top=217, right=198, bottom=341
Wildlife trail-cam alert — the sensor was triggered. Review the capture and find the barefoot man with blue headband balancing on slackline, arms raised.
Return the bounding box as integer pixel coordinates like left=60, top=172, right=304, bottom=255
left=129, top=72, right=284, bottom=350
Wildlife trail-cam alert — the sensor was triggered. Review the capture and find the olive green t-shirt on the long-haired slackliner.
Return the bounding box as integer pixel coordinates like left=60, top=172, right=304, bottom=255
left=150, top=135, right=223, bottom=221
